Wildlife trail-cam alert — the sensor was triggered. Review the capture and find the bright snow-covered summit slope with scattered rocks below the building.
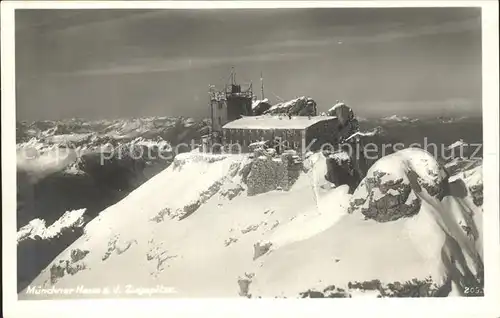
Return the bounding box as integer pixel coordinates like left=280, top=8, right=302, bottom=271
left=19, top=149, right=483, bottom=299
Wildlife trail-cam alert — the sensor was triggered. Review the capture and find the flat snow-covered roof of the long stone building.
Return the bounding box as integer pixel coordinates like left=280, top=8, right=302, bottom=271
left=222, top=115, right=337, bottom=129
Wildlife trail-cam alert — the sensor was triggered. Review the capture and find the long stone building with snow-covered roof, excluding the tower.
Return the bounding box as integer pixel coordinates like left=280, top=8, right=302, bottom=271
left=222, top=115, right=339, bottom=152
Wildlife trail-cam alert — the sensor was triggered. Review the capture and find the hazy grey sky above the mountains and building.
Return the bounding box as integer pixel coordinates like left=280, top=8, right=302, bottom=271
left=16, top=8, right=481, bottom=120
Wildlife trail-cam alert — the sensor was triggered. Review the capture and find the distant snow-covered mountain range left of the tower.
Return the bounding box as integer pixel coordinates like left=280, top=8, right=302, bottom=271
left=16, top=117, right=208, bottom=177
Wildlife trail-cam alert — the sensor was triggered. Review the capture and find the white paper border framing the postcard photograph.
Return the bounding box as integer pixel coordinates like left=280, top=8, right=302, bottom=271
left=1, top=0, right=500, bottom=318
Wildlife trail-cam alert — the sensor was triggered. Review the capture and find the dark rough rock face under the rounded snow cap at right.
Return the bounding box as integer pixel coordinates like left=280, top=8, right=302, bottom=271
left=349, top=171, right=421, bottom=222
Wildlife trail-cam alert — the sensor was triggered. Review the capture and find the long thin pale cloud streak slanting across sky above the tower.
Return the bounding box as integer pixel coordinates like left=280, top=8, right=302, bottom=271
left=61, top=52, right=318, bottom=76
